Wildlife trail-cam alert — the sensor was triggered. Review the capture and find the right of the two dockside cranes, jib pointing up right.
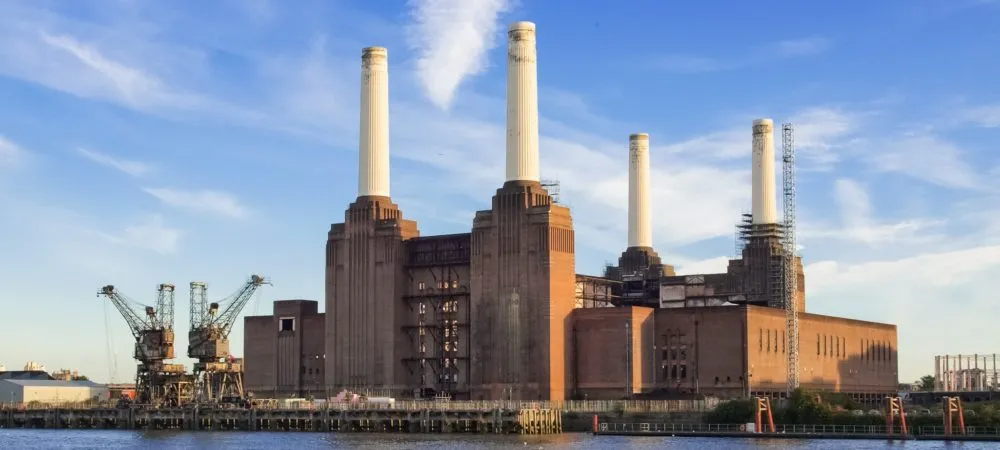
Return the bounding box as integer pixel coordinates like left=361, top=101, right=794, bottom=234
left=188, top=275, right=271, bottom=402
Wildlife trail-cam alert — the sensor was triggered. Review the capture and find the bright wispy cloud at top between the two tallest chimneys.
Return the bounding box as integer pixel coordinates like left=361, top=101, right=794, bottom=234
left=408, top=0, right=510, bottom=109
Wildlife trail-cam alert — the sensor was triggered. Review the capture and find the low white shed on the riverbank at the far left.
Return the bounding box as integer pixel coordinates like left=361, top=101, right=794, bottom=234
left=0, top=380, right=108, bottom=403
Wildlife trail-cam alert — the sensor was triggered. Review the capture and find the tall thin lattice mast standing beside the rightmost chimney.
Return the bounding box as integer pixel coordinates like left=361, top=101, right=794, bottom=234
left=781, top=123, right=799, bottom=394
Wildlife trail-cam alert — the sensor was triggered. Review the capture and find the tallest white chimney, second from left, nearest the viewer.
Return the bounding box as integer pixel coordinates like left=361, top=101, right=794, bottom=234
left=507, top=22, right=539, bottom=181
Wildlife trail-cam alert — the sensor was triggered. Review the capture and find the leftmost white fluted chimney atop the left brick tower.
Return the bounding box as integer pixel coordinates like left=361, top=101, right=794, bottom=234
left=358, top=47, right=389, bottom=197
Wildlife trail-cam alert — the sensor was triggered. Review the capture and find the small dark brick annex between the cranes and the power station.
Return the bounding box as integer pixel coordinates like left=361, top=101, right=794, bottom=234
left=243, top=300, right=326, bottom=398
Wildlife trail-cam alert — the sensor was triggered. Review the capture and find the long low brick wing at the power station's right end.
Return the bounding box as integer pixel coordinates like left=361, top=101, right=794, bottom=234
left=570, top=305, right=898, bottom=400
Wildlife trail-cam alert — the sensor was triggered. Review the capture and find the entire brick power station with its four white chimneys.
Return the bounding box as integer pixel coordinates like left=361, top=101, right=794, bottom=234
left=245, top=22, right=897, bottom=400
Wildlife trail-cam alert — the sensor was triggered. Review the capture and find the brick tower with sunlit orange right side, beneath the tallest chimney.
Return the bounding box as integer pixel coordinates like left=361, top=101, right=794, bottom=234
left=470, top=182, right=576, bottom=400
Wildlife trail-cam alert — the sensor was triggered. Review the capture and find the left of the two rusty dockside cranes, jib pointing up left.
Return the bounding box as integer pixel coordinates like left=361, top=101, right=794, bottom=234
left=97, top=283, right=192, bottom=406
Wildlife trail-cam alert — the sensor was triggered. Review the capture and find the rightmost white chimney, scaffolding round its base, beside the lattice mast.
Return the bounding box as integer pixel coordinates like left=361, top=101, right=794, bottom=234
left=752, top=119, right=778, bottom=224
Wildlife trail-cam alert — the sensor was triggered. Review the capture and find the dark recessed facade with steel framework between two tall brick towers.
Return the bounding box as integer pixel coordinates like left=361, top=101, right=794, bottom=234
left=403, top=234, right=471, bottom=399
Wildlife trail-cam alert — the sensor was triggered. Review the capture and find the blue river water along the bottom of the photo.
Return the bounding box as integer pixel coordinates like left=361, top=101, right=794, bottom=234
left=0, top=429, right=1000, bottom=450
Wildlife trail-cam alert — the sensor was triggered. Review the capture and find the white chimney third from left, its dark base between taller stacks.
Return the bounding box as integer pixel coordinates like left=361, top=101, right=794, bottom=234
left=628, top=133, right=653, bottom=247
